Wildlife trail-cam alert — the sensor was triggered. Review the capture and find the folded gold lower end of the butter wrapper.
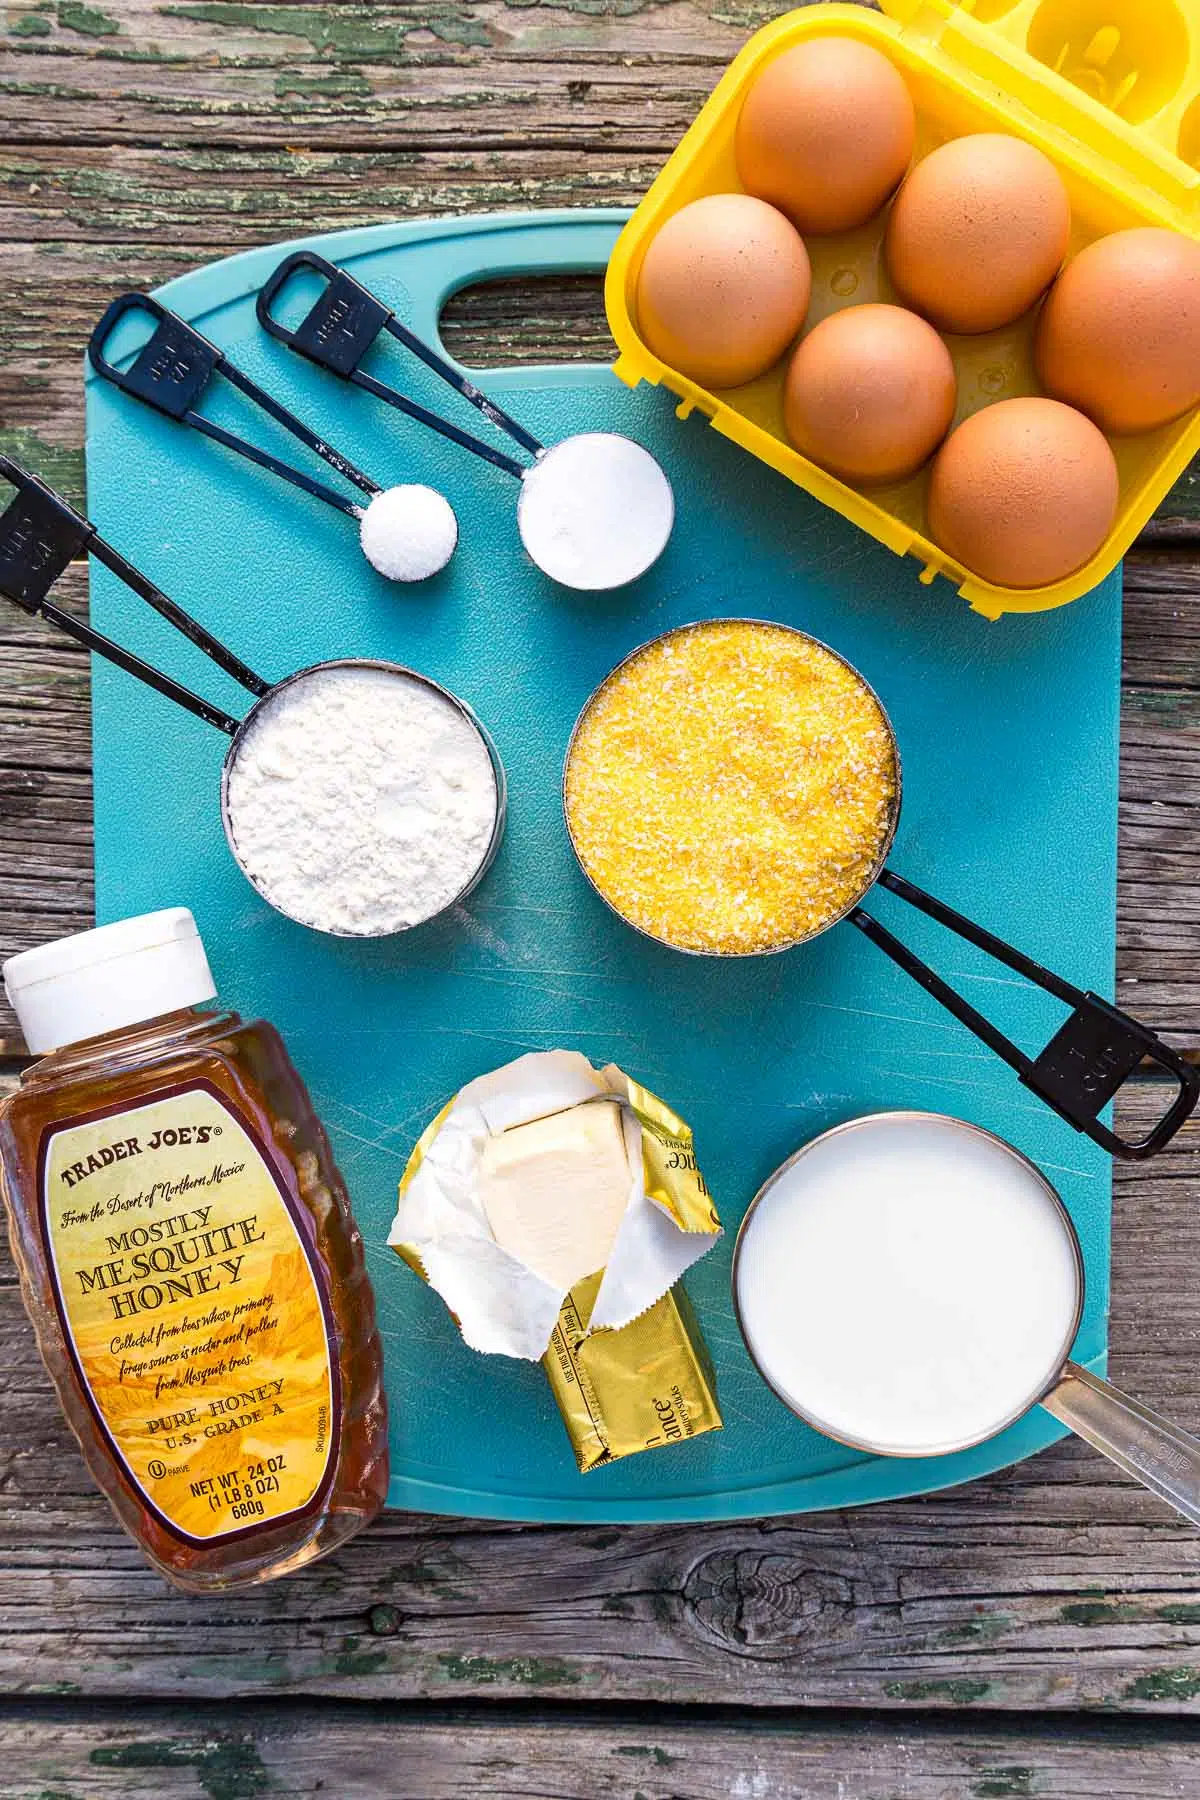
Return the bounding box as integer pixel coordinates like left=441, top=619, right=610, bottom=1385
left=542, top=1273, right=721, bottom=1474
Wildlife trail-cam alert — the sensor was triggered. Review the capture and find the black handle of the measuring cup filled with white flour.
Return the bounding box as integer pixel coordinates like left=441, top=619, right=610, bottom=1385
left=0, top=455, right=248, bottom=736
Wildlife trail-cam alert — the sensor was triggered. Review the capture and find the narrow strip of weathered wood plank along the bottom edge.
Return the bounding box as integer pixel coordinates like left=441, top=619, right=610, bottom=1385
left=0, top=1705, right=1200, bottom=1800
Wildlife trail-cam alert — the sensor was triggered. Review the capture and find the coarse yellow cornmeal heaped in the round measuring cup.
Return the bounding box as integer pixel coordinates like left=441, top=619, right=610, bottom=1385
left=565, top=619, right=896, bottom=954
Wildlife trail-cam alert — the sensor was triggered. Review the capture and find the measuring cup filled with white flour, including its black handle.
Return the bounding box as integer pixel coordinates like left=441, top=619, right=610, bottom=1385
left=0, top=455, right=506, bottom=938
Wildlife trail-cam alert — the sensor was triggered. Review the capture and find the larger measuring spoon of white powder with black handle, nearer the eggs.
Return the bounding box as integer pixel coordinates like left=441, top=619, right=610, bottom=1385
left=257, top=250, right=675, bottom=590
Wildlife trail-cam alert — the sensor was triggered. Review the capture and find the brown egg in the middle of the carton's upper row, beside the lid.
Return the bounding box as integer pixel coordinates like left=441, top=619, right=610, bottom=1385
left=887, top=131, right=1070, bottom=331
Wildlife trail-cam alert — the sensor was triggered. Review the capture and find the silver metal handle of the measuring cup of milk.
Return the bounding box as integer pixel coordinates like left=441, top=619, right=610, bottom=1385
left=1042, top=1363, right=1200, bottom=1525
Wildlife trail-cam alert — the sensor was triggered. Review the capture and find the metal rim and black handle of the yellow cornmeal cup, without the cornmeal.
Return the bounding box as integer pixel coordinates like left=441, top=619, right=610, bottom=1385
left=563, top=617, right=1200, bottom=1159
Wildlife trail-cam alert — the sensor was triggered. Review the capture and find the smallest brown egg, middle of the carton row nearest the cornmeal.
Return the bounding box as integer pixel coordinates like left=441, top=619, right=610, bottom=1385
left=783, top=306, right=957, bottom=484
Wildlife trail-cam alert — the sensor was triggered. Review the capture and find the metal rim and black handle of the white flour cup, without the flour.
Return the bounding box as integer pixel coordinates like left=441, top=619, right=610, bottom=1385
left=0, top=455, right=507, bottom=938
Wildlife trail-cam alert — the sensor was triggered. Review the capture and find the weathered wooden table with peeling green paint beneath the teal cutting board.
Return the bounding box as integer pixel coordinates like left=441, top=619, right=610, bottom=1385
left=0, top=0, right=1200, bottom=1800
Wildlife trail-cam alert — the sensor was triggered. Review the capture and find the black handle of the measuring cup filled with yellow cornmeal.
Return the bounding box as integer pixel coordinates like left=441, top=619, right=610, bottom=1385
left=849, top=869, right=1200, bottom=1161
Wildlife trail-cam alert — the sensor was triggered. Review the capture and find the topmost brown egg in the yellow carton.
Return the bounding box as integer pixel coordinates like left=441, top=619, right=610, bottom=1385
left=736, top=38, right=916, bottom=232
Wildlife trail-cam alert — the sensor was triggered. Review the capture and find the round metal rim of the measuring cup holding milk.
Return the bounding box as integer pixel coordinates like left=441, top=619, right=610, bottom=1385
left=729, top=1107, right=1087, bottom=1462
